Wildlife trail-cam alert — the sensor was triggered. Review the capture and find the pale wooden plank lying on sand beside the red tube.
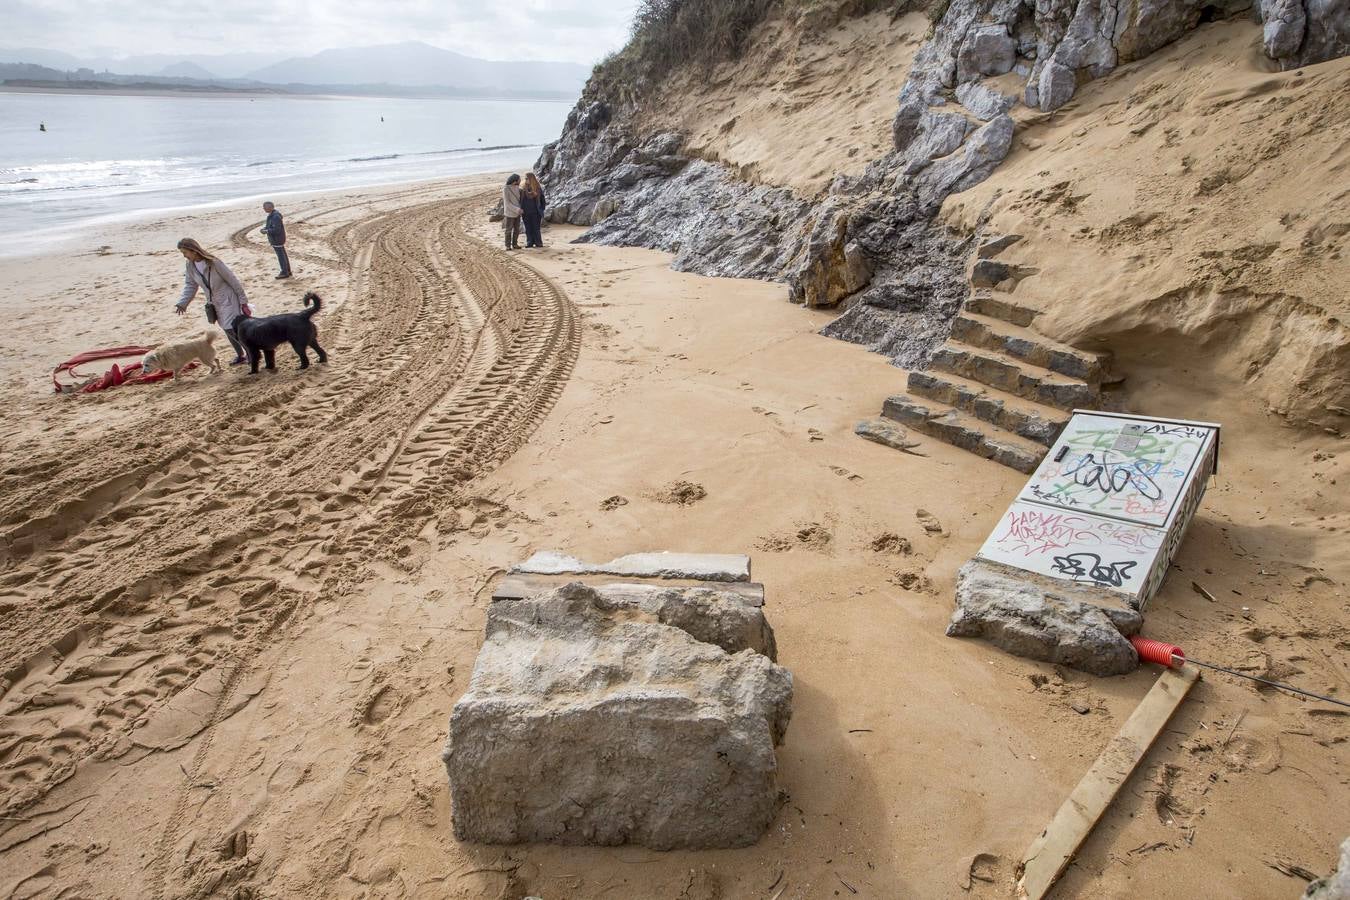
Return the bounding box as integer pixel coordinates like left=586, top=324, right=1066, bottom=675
left=1018, top=667, right=1200, bottom=900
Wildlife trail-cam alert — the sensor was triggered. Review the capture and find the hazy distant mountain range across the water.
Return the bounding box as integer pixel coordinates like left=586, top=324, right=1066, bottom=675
left=0, top=40, right=590, bottom=97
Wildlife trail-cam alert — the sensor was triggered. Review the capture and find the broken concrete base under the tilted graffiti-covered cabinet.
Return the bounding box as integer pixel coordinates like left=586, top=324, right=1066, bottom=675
left=946, top=559, right=1143, bottom=675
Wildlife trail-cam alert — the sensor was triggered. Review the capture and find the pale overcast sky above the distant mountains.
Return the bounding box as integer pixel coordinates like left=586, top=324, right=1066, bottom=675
left=0, top=0, right=637, bottom=63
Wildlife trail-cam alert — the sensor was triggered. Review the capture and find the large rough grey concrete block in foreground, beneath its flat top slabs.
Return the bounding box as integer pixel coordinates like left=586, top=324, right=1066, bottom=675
left=441, top=583, right=792, bottom=850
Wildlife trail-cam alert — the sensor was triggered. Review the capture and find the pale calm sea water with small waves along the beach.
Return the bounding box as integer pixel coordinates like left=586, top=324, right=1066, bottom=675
left=0, top=92, right=571, bottom=256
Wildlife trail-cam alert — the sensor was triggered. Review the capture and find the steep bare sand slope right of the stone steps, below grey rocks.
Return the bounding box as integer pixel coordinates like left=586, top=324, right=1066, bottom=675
left=945, top=22, right=1350, bottom=431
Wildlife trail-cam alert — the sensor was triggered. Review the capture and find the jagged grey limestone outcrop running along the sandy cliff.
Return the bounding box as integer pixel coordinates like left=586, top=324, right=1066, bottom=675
left=536, top=0, right=1350, bottom=367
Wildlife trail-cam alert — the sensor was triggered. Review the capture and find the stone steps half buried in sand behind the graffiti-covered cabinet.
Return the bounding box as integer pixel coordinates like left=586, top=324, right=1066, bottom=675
left=859, top=291, right=1118, bottom=474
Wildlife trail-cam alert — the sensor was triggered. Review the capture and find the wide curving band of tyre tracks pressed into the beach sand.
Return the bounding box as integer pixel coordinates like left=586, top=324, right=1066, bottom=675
left=0, top=190, right=579, bottom=896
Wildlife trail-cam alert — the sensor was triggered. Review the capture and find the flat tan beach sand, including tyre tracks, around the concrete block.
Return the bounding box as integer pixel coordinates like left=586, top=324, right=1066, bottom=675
left=0, top=163, right=1350, bottom=900
